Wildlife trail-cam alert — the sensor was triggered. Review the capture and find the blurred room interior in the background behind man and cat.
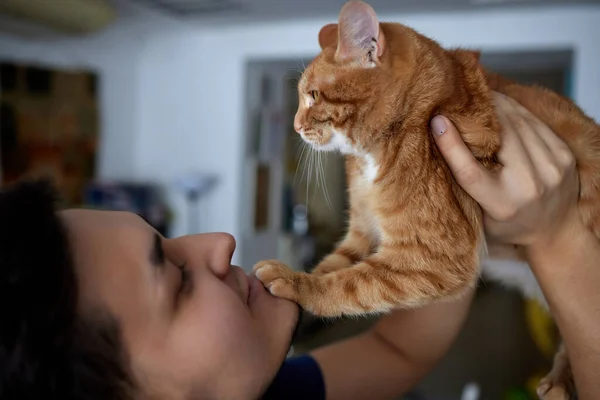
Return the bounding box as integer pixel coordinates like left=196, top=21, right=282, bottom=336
left=0, top=0, right=600, bottom=400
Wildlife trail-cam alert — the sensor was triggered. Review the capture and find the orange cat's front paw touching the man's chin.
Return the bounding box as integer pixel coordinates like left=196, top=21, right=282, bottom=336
left=252, top=260, right=298, bottom=302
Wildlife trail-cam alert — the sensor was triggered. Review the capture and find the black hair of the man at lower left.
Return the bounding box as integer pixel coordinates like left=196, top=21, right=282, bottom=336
left=0, top=180, right=133, bottom=400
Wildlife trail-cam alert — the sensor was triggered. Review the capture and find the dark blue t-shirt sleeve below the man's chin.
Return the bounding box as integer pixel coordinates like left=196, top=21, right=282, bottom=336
left=262, top=355, right=325, bottom=400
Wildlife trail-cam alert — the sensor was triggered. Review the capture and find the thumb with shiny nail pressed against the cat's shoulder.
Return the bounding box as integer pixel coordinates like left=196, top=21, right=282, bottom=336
left=431, top=115, right=497, bottom=205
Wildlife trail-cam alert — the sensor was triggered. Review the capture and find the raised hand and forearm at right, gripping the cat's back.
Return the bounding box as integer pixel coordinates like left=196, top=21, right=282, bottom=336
left=432, top=93, right=600, bottom=400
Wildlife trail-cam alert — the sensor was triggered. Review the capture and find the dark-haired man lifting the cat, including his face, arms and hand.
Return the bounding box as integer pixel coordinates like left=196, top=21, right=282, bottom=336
left=0, top=97, right=600, bottom=400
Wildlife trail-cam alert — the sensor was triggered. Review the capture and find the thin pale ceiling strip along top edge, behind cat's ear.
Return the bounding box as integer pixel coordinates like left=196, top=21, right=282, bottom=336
left=120, top=0, right=600, bottom=23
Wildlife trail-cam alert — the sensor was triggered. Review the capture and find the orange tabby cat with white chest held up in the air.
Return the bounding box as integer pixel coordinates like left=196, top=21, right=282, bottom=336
left=254, top=1, right=600, bottom=396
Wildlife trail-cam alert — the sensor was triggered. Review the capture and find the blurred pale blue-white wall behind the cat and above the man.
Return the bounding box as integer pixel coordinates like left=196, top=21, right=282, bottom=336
left=0, top=0, right=600, bottom=256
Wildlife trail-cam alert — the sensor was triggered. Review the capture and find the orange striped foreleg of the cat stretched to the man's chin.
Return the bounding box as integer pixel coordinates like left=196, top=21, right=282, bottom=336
left=254, top=245, right=478, bottom=317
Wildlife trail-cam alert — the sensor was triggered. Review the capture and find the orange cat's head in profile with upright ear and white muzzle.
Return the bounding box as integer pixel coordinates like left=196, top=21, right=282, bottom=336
left=294, top=1, right=414, bottom=154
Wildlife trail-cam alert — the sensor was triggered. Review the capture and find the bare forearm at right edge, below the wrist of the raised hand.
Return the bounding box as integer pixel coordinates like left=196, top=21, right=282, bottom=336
left=528, top=215, right=600, bottom=400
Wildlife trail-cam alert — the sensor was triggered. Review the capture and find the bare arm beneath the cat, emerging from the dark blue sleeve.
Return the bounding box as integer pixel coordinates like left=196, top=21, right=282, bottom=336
left=311, top=290, right=474, bottom=400
